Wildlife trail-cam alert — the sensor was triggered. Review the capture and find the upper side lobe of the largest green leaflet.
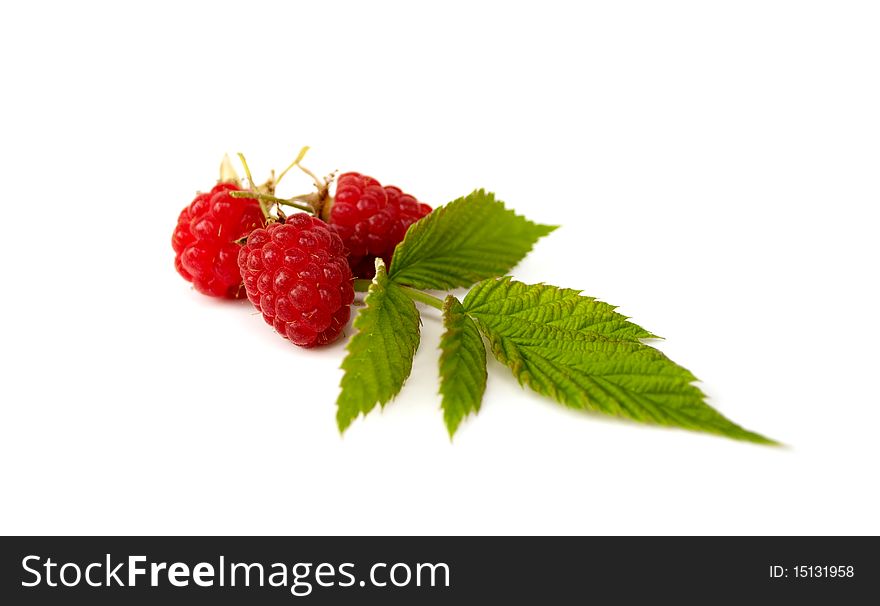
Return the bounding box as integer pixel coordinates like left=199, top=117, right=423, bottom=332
left=464, top=277, right=657, bottom=341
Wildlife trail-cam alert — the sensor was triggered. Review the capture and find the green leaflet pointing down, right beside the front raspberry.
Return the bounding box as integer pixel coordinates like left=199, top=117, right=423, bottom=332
left=336, top=259, right=419, bottom=431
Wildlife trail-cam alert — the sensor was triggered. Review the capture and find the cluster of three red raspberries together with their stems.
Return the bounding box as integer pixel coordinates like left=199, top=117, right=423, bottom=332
left=171, top=154, right=431, bottom=347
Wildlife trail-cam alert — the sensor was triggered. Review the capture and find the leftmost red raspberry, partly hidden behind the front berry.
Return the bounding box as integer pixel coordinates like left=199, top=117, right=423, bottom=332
left=171, top=183, right=265, bottom=299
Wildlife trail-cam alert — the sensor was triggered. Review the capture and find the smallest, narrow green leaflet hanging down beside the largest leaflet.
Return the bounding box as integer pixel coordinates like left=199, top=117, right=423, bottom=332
left=440, top=295, right=486, bottom=438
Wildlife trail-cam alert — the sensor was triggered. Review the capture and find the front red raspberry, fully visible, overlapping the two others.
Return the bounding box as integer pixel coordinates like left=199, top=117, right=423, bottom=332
left=238, top=214, right=354, bottom=347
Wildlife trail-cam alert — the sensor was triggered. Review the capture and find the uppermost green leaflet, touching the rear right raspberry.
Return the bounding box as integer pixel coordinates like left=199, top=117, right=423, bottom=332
left=388, top=189, right=556, bottom=290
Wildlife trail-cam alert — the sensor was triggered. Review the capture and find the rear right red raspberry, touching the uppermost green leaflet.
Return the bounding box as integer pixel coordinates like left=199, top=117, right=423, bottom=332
left=322, top=173, right=431, bottom=278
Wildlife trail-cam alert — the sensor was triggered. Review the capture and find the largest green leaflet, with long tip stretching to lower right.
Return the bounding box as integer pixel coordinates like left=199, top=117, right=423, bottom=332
left=464, top=280, right=774, bottom=444
